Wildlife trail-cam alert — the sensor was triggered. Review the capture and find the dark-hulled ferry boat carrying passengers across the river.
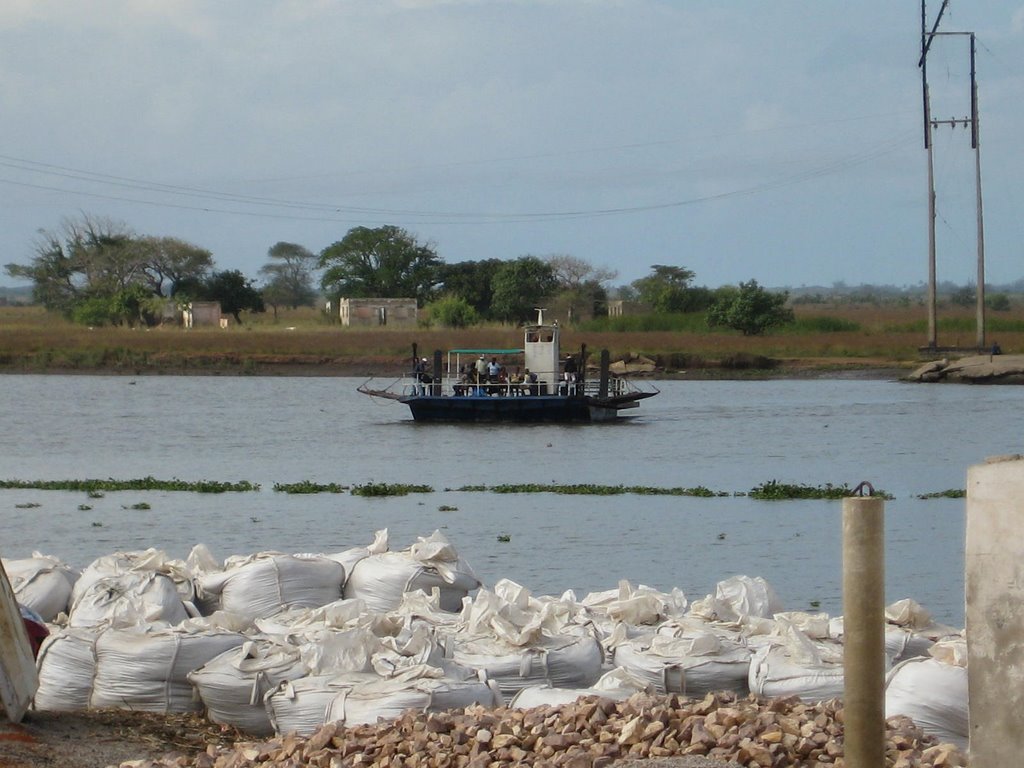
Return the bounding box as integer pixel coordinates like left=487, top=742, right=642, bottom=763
left=358, top=309, right=658, bottom=423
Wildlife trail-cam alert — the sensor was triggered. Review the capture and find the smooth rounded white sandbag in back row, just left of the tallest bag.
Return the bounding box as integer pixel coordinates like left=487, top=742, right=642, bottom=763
left=198, top=552, right=345, bottom=618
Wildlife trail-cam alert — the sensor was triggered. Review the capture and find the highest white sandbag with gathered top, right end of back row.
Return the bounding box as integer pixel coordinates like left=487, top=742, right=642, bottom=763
left=345, top=530, right=480, bottom=612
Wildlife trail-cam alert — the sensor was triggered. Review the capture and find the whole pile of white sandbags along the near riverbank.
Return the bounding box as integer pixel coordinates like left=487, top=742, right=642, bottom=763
left=4, top=530, right=967, bottom=741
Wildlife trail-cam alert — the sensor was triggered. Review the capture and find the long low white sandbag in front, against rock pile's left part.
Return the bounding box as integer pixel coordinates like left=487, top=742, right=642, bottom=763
left=265, top=668, right=501, bottom=736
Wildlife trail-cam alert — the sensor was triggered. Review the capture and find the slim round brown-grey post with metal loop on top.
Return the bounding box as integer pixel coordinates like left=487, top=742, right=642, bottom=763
left=843, top=497, right=886, bottom=768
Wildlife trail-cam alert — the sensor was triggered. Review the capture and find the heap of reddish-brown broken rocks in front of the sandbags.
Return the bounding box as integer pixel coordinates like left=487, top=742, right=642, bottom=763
left=124, top=693, right=967, bottom=768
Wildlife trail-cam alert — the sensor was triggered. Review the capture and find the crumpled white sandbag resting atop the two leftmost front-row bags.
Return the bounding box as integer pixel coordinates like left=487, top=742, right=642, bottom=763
left=68, top=570, right=189, bottom=627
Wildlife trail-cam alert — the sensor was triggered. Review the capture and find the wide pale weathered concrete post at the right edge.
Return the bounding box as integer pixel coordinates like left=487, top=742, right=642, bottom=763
left=965, top=456, right=1024, bottom=768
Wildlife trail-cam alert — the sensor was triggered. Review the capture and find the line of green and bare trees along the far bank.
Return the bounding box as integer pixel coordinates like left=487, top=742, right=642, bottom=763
left=5, top=216, right=793, bottom=334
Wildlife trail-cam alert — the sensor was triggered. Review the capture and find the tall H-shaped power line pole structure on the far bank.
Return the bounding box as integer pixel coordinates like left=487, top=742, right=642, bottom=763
left=918, top=0, right=985, bottom=351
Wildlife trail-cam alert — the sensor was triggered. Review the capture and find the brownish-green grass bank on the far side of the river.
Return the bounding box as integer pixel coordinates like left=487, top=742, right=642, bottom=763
left=0, top=305, right=1024, bottom=378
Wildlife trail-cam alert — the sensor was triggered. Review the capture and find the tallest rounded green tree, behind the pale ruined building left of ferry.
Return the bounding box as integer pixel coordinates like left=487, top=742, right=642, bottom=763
left=318, top=225, right=441, bottom=306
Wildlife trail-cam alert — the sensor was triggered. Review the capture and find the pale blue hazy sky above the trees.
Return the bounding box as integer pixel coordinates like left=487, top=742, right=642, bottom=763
left=0, top=0, right=1024, bottom=287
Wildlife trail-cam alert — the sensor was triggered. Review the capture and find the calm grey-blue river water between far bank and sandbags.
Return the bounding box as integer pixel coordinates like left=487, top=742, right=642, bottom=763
left=0, top=376, right=1024, bottom=626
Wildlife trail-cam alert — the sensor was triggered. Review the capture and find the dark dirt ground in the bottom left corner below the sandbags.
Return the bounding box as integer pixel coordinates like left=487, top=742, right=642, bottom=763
left=0, top=710, right=239, bottom=768
